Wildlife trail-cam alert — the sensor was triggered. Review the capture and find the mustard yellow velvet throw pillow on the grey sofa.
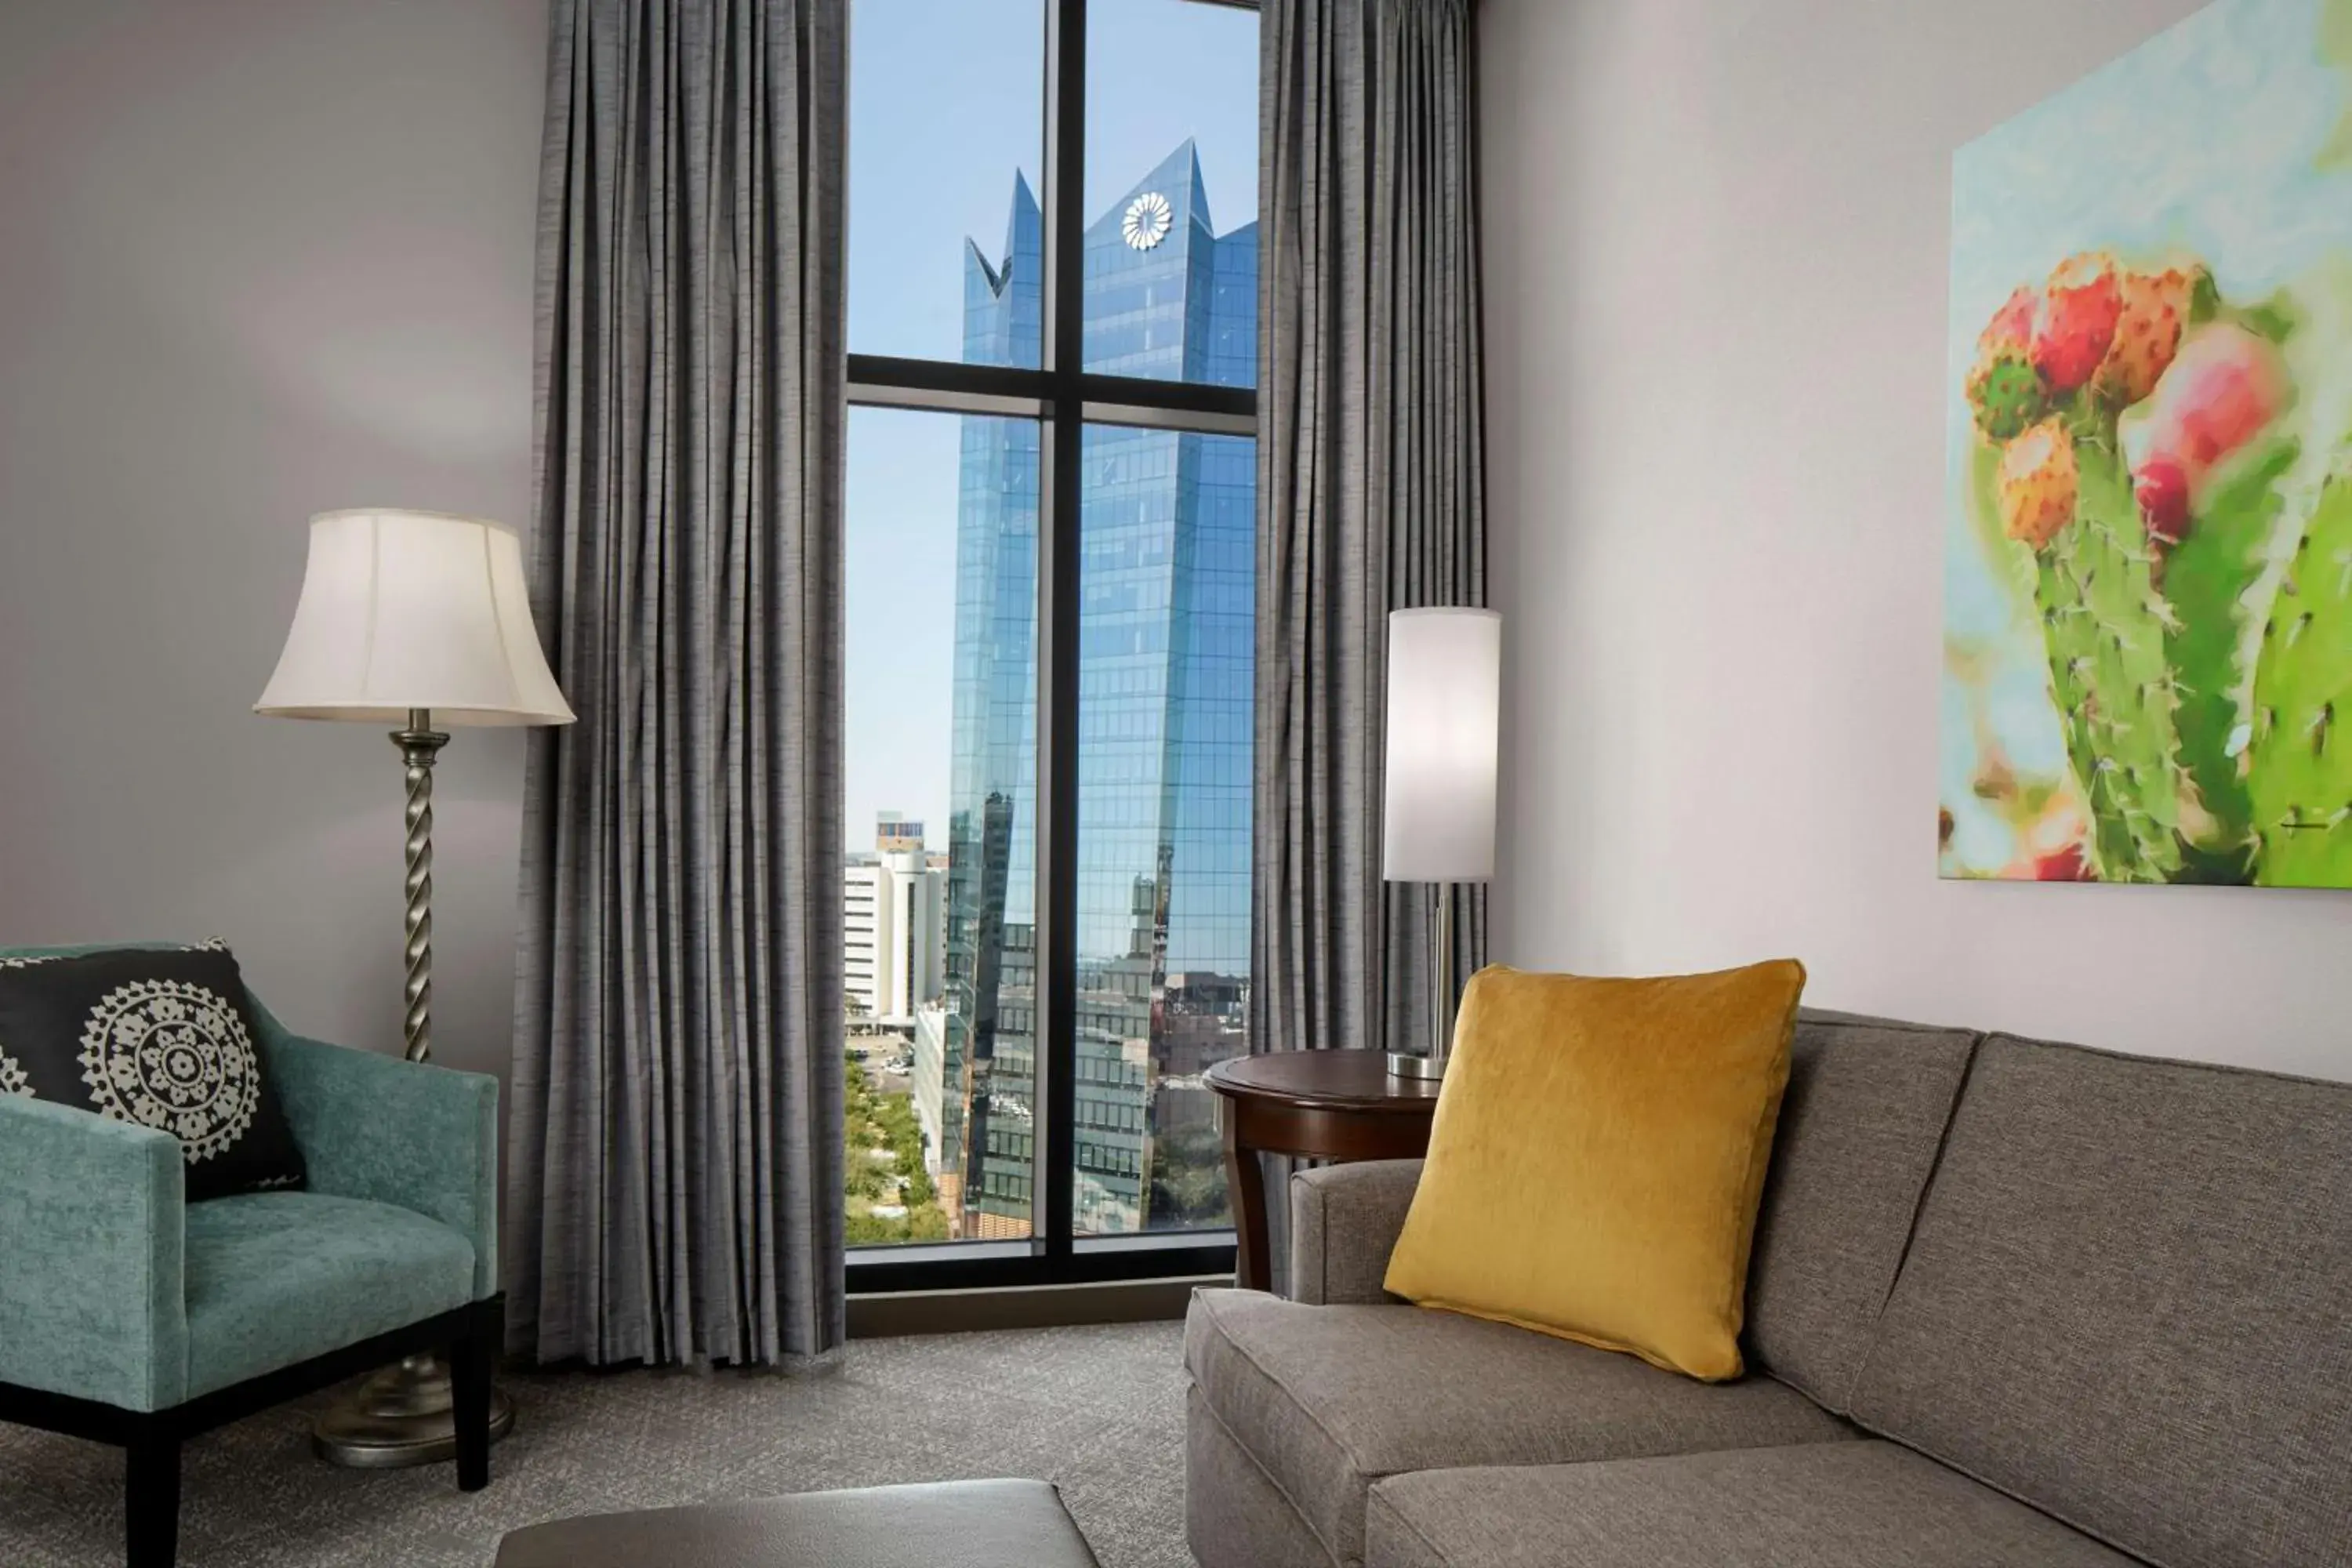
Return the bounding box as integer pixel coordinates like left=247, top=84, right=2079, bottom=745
left=1388, top=959, right=1804, bottom=1382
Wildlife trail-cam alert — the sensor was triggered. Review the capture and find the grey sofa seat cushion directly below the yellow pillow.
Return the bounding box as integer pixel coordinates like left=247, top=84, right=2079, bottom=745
left=1185, top=1290, right=1853, bottom=1566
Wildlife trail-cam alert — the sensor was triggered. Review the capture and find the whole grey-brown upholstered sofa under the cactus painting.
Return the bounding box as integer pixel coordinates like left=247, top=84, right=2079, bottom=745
left=1185, top=1011, right=2352, bottom=1568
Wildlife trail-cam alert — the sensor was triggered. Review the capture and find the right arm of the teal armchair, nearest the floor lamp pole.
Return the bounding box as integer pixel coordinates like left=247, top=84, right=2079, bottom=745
left=256, top=1008, right=499, bottom=1300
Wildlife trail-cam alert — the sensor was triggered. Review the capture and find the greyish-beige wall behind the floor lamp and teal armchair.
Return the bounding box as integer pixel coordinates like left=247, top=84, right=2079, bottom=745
left=0, top=0, right=546, bottom=1091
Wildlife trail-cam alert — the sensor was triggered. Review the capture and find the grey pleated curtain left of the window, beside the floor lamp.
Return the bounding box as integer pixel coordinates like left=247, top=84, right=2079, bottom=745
left=506, top=0, right=847, bottom=1366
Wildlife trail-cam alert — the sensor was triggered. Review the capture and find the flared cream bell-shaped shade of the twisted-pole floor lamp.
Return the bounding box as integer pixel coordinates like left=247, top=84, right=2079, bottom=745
left=254, top=510, right=572, bottom=724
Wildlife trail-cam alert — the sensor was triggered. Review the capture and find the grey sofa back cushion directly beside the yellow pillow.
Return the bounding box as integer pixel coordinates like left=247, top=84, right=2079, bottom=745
left=1745, top=1008, right=1976, bottom=1413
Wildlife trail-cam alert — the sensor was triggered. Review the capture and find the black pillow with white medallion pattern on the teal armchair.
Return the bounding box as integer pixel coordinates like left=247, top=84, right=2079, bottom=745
left=0, top=942, right=303, bottom=1201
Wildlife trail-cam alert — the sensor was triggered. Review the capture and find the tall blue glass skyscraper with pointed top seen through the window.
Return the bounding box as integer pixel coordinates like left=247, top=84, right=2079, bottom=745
left=941, top=141, right=1258, bottom=1236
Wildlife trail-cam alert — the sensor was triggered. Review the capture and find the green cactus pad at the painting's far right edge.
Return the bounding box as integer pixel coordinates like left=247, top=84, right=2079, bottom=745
left=2249, top=475, right=2352, bottom=886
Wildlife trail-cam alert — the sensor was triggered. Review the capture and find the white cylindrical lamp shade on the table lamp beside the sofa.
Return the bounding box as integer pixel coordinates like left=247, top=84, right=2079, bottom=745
left=1381, top=609, right=1503, bottom=881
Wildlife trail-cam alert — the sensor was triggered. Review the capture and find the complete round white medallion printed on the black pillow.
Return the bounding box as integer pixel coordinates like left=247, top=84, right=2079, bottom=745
left=82, top=980, right=261, bottom=1166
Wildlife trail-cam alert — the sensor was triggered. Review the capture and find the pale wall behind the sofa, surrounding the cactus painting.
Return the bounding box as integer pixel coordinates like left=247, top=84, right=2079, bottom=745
left=1482, top=0, right=2352, bottom=1076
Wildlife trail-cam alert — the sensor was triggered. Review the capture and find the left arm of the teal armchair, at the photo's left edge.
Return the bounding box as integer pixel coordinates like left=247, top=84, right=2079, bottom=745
left=0, top=1095, right=188, bottom=1410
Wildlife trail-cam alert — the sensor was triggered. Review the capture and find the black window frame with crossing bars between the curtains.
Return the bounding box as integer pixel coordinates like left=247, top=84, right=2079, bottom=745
left=847, top=0, right=1263, bottom=1295
